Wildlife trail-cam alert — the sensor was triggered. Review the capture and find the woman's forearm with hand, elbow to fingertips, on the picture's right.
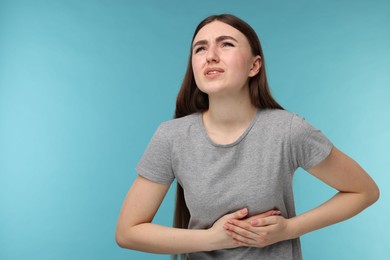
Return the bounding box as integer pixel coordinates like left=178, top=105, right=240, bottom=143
left=219, top=189, right=378, bottom=247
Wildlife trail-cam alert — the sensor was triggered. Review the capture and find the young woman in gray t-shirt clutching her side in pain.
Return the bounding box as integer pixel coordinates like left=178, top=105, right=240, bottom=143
left=116, top=14, right=379, bottom=259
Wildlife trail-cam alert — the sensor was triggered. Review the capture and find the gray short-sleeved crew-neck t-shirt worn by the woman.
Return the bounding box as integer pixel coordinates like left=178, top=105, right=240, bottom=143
left=136, top=109, right=333, bottom=260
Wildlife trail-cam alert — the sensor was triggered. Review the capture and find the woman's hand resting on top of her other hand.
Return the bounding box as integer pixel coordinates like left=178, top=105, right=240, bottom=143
left=224, top=216, right=294, bottom=247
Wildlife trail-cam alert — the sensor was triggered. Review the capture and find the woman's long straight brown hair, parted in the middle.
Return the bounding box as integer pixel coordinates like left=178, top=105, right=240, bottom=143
left=174, top=14, right=283, bottom=258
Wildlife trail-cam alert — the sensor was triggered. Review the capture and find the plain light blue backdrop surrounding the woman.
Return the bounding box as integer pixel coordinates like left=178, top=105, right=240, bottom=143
left=0, top=0, right=390, bottom=260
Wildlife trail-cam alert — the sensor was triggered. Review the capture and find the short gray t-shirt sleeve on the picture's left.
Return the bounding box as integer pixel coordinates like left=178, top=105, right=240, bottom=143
left=136, top=125, right=174, bottom=184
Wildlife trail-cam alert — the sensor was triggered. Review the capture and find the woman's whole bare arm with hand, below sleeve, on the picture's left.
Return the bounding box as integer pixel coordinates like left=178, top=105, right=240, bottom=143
left=115, top=176, right=247, bottom=254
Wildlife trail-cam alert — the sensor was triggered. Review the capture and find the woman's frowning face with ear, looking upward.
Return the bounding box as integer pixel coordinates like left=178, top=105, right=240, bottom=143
left=192, top=21, right=261, bottom=95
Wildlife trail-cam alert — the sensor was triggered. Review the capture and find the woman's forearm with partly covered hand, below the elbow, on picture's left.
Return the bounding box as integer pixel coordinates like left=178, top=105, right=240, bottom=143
left=116, top=208, right=250, bottom=254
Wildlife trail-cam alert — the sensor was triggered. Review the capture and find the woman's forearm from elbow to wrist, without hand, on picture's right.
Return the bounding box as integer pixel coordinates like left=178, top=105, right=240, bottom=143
left=290, top=191, right=379, bottom=237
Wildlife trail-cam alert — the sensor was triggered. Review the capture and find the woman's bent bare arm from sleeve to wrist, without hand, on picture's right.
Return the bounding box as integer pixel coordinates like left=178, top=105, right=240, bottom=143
left=293, top=148, right=379, bottom=236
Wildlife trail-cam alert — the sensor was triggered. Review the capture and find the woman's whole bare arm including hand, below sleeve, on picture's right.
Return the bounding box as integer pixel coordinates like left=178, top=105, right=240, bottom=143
left=226, top=148, right=379, bottom=247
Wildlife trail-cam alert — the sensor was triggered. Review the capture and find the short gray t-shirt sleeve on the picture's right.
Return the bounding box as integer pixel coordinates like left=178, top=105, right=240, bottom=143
left=290, top=114, right=333, bottom=170
